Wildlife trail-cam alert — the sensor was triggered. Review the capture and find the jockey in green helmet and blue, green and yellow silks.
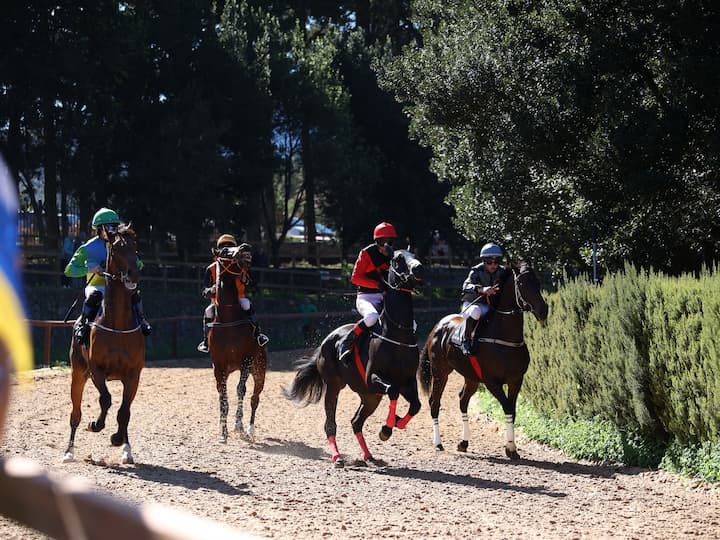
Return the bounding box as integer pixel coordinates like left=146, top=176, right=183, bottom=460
left=64, top=208, right=152, bottom=345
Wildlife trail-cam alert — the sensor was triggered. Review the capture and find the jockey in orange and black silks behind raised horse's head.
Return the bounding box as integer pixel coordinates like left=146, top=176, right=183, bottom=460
left=197, top=234, right=270, bottom=353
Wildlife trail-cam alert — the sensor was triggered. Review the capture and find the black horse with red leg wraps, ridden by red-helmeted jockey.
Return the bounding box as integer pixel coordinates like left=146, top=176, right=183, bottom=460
left=285, top=250, right=423, bottom=467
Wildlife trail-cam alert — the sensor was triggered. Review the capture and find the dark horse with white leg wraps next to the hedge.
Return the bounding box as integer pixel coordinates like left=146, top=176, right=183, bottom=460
left=418, top=262, right=548, bottom=460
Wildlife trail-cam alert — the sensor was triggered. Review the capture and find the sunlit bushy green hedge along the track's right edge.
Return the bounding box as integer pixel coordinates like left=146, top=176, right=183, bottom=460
left=522, top=265, right=720, bottom=472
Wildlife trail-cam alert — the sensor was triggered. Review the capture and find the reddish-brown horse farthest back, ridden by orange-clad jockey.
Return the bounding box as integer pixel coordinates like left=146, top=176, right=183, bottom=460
left=208, top=249, right=268, bottom=443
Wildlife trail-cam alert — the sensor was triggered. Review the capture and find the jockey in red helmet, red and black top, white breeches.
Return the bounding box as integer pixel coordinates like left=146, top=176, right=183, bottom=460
left=338, top=221, right=397, bottom=365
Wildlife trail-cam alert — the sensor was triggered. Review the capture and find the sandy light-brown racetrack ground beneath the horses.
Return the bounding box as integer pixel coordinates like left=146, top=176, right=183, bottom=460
left=0, top=353, right=720, bottom=539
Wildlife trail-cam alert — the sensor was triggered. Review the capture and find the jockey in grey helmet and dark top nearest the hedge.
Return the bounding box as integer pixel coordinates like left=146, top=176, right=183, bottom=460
left=462, top=243, right=504, bottom=354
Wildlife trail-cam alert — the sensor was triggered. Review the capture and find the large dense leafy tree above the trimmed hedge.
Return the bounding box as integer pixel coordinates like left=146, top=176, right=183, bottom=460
left=378, top=0, right=720, bottom=273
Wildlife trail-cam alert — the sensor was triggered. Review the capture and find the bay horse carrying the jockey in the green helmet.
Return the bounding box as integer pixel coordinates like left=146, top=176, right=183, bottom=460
left=63, top=225, right=145, bottom=463
